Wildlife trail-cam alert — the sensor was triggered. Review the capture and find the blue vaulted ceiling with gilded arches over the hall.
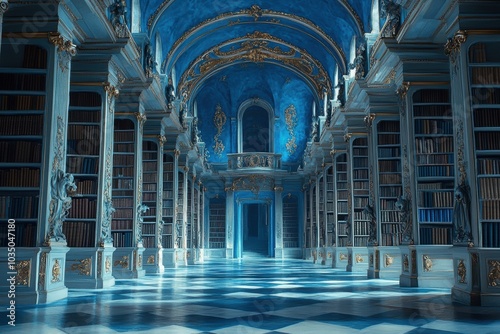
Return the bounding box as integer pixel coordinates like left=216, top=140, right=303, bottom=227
left=134, top=0, right=377, bottom=164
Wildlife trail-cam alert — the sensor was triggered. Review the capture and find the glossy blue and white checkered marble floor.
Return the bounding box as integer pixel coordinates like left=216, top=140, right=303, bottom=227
left=0, top=258, right=500, bottom=334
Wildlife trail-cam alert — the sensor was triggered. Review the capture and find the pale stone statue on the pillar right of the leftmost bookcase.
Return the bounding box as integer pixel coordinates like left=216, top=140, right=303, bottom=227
left=48, top=169, right=77, bottom=241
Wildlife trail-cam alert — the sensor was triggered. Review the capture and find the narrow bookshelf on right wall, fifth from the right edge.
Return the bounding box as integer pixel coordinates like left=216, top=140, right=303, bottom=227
left=334, top=153, right=349, bottom=247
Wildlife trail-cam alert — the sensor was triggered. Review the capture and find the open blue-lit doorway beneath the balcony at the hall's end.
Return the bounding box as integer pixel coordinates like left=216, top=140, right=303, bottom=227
left=243, top=203, right=269, bottom=258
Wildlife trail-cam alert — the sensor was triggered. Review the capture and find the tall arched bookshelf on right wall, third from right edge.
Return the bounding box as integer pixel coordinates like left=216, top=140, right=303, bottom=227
left=377, top=120, right=403, bottom=246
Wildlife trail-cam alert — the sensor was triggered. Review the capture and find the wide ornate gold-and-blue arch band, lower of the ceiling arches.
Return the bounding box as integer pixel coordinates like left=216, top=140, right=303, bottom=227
left=178, top=31, right=332, bottom=101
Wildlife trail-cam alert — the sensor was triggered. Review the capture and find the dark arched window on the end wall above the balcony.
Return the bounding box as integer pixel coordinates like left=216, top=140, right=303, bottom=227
left=238, top=99, right=274, bottom=153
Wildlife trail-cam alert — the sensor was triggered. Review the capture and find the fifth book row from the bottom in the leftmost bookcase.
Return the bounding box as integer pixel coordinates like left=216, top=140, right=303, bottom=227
left=0, top=114, right=43, bottom=136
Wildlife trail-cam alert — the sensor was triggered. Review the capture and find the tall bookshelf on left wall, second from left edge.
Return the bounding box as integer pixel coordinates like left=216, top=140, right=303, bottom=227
left=63, top=92, right=102, bottom=247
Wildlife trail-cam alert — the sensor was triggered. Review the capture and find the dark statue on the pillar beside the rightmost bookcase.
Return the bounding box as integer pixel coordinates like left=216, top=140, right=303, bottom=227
left=453, top=183, right=472, bottom=243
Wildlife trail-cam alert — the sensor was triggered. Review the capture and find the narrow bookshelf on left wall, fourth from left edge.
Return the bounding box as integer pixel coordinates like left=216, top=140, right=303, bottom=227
left=142, top=139, right=158, bottom=248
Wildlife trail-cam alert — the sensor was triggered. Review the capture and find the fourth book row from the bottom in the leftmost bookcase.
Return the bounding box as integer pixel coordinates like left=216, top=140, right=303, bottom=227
left=0, top=140, right=42, bottom=163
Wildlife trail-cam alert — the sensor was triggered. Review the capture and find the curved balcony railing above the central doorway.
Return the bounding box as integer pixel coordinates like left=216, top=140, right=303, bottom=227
left=227, top=152, right=281, bottom=170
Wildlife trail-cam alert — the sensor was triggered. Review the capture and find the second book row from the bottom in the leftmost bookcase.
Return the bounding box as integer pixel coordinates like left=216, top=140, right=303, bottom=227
left=0, top=196, right=39, bottom=219
